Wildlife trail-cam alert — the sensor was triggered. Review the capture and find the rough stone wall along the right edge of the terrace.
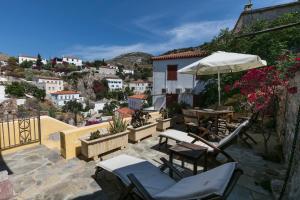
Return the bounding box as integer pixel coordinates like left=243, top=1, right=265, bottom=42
left=277, top=72, right=300, bottom=199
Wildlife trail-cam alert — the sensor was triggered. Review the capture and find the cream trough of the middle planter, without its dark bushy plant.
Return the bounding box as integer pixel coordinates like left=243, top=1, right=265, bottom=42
left=127, top=122, right=157, bottom=142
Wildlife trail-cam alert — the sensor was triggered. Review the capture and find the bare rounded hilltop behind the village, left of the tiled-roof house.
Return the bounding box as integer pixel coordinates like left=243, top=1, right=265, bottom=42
left=106, top=52, right=153, bottom=69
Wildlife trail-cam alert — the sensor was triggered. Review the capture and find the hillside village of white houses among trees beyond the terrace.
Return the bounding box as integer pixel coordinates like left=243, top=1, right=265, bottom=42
left=0, top=52, right=152, bottom=125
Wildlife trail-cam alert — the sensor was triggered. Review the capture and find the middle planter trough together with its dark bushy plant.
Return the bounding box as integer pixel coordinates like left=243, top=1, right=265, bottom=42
left=128, top=110, right=157, bottom=142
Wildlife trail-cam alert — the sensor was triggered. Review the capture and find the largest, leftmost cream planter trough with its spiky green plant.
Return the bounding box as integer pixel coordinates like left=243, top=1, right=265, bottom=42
left=80, top=117, right=129, bottom=160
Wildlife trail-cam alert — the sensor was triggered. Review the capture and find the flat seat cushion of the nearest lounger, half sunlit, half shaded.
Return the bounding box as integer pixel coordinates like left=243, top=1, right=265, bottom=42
left=97, top=154, right=176, bottom=195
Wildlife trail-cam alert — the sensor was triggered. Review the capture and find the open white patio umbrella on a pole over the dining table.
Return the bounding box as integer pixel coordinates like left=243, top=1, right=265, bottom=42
left=178, top=51, right=267, bottom=106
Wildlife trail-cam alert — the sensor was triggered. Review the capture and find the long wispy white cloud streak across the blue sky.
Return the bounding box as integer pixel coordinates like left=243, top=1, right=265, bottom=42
left=63, top=20, right=234, bottom=60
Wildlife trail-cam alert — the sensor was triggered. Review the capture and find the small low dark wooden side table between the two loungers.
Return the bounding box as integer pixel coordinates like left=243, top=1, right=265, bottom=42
left=169, top=142, right=207, bottom=177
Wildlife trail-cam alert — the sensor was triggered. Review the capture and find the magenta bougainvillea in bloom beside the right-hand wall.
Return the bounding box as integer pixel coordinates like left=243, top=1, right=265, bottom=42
left=229, top=57, right=300, bottom=112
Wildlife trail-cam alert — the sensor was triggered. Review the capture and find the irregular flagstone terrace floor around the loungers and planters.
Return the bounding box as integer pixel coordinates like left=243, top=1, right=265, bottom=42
left=0, top=131, right=282, bottom=200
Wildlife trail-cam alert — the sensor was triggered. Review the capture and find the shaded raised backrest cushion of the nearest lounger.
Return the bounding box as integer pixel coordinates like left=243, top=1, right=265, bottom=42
left=154, top=162, right=237, bottom=200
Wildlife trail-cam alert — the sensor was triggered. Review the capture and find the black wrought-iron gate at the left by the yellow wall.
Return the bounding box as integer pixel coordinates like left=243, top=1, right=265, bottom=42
left=0, top=112, right=41, bottom=151
